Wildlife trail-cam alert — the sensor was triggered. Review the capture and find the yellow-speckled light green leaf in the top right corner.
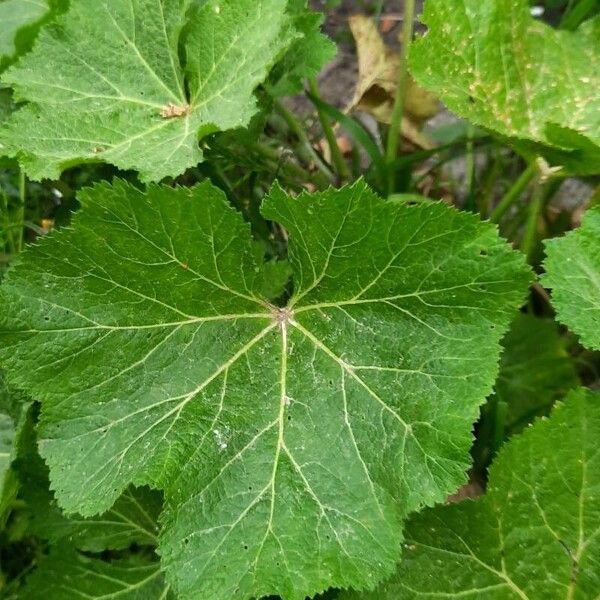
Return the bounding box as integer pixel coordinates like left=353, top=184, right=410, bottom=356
left=410, top=0, right=600, bottom=172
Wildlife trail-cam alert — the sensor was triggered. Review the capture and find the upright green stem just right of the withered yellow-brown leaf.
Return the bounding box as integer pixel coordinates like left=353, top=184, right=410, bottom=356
left=386, top=0, right=415, bottom=194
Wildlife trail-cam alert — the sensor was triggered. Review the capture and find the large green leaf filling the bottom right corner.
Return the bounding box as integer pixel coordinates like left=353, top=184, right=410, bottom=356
left=342, top=389, right=600, bottom=600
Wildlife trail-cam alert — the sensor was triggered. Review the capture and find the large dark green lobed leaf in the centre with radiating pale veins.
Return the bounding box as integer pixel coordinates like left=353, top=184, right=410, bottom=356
left=0, top=181, right=530, bottom=600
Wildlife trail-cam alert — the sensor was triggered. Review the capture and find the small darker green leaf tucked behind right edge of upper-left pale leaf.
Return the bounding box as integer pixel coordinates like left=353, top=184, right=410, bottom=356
left=268, top=0, right=336, bottom=97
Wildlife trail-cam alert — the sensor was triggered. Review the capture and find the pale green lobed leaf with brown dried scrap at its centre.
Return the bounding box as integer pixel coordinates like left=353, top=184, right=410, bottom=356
left=0, top=0, right=297, bottom=181
